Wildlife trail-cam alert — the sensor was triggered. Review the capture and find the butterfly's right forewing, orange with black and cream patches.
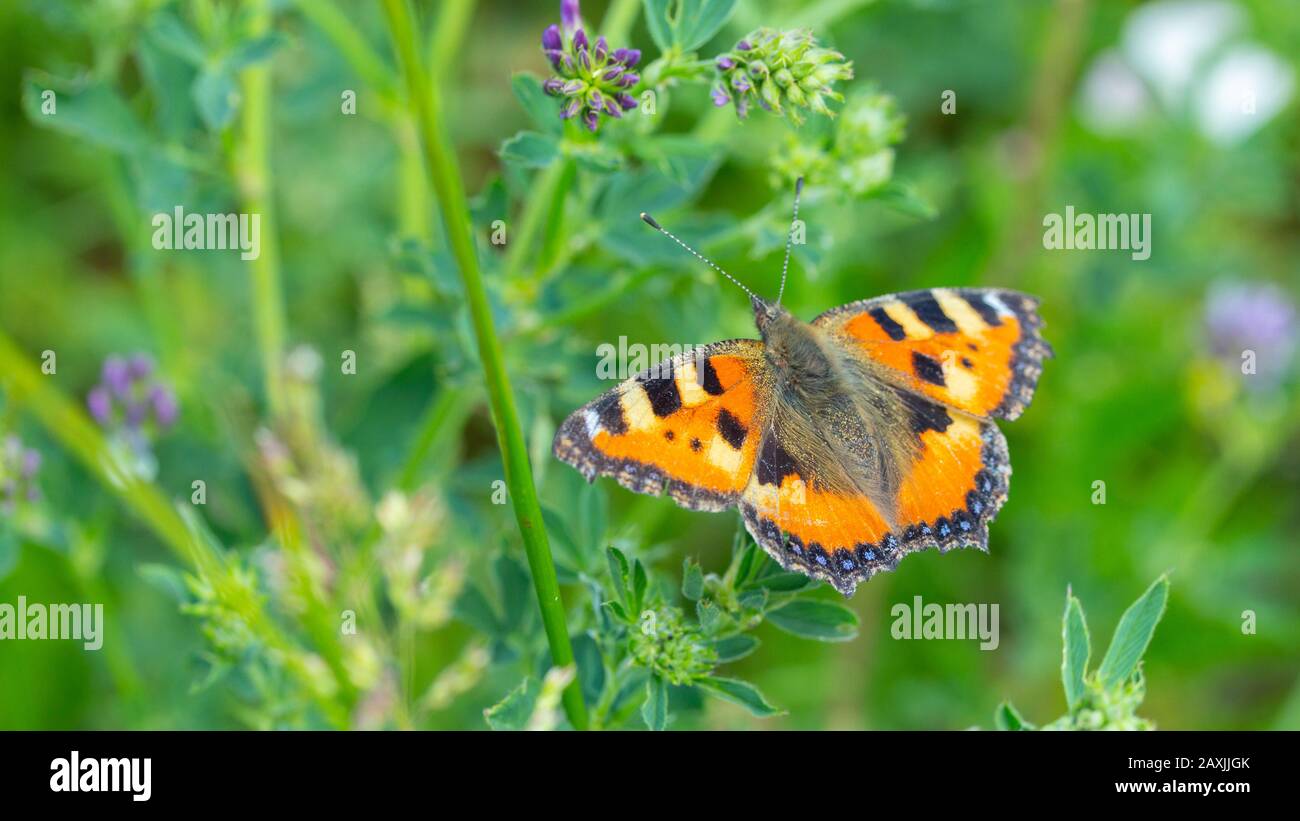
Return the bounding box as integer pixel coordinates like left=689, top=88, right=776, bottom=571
left=813, top=288, right=1052, bottom=420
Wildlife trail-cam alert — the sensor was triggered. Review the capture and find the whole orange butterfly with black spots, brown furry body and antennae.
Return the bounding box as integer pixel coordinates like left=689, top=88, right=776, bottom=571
left=553, top=181, right=1053, bottom=596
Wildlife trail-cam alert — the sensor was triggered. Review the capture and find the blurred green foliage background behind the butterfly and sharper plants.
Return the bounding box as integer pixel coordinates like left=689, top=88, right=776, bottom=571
left=0, top=0, right=1300, bottom=729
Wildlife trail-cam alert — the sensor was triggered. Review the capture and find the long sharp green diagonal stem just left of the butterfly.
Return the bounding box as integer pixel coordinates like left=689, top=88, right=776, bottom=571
left=384, top=0, right=588, bottom=730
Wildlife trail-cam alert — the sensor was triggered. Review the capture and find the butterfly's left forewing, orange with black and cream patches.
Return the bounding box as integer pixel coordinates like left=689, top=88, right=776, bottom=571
left=553, top=339, right=768, bottom=511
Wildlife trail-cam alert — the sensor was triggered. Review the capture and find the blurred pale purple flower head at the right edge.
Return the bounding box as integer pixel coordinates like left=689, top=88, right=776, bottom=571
left=1205, top=282, right=1297, bottom=386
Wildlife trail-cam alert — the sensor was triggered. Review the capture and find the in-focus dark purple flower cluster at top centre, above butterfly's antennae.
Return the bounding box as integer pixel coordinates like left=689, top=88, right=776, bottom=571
left=542, top=0, right=641, bottom=131
